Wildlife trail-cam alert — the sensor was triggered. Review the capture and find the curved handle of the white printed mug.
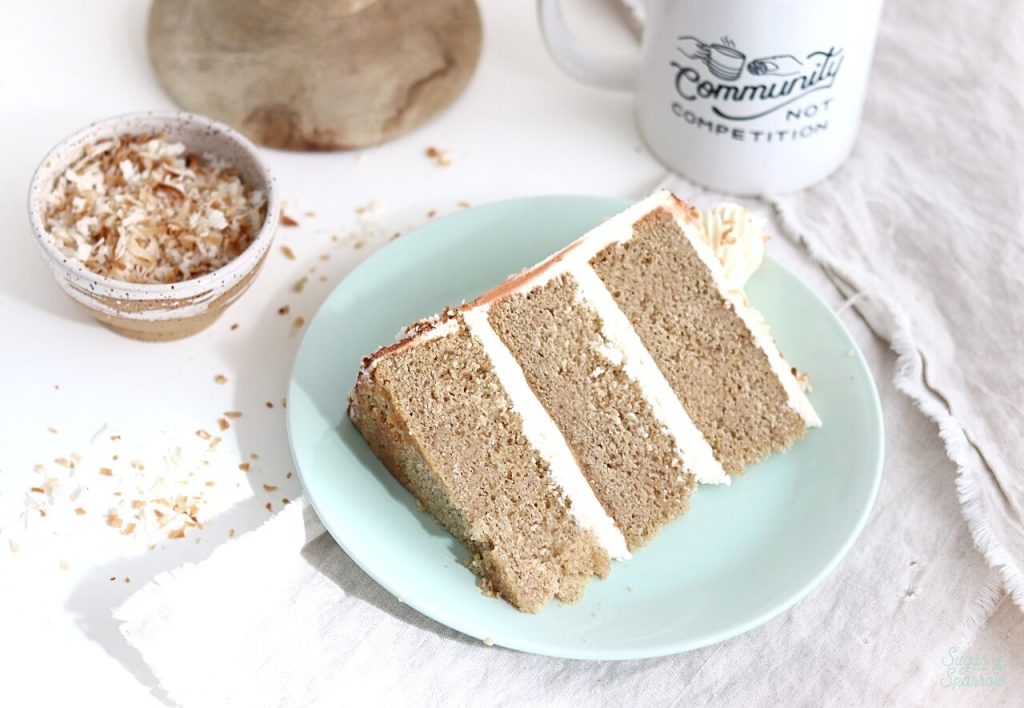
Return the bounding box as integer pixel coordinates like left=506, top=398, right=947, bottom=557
left=537, top=0, right=640, bottom=91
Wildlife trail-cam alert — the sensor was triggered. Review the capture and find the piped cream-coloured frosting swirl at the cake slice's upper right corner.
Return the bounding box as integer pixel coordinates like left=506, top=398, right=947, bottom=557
left=700, top=204, right=765, bottom=289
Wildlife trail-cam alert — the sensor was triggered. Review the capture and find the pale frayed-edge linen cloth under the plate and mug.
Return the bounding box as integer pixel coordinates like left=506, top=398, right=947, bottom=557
left=116, top=1, right=1024, bottom=707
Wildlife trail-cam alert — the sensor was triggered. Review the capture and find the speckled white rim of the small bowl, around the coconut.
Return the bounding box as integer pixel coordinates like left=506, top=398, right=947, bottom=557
left=28, top=110, right=281, bottom=298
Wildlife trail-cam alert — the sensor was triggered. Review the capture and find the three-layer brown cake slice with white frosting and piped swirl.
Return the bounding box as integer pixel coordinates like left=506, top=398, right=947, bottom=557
left=349, top=192, right=820, bottom=612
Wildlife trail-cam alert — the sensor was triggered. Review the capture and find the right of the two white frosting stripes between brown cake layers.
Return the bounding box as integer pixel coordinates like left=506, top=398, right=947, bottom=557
left=569, top=262, right=730, bottom=485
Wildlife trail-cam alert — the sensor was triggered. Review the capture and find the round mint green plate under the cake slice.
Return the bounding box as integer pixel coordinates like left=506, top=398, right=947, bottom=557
left=288, top=192, right=883, bottom=659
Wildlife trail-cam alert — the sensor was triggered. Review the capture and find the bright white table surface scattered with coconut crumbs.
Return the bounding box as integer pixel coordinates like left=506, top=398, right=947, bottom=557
left=0, top=0, right=664, bottom=706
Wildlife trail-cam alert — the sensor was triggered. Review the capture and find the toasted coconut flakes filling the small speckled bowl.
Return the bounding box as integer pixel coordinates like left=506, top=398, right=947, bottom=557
left=44, top=134, right=266, bottom=283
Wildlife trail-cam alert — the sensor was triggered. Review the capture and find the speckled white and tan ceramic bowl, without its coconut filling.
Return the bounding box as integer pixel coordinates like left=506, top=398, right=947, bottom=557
left=29, top=112, right=281, bottom=340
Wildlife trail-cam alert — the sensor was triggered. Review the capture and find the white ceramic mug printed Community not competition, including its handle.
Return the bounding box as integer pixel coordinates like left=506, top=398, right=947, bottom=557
left=538, top=0, right=882, bottom=195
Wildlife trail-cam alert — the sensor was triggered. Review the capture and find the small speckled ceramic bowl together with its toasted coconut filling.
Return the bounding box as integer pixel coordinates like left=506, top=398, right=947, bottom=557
left=29, top=112, right=280, bottom=340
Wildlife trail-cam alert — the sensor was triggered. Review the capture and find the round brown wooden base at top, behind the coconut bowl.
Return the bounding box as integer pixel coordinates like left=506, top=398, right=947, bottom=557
left=148, top=0, right=481, bottom=150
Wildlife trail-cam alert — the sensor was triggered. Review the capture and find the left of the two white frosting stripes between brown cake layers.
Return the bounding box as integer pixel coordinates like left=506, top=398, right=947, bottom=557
left=463, top=305, right=631, bottom=560
